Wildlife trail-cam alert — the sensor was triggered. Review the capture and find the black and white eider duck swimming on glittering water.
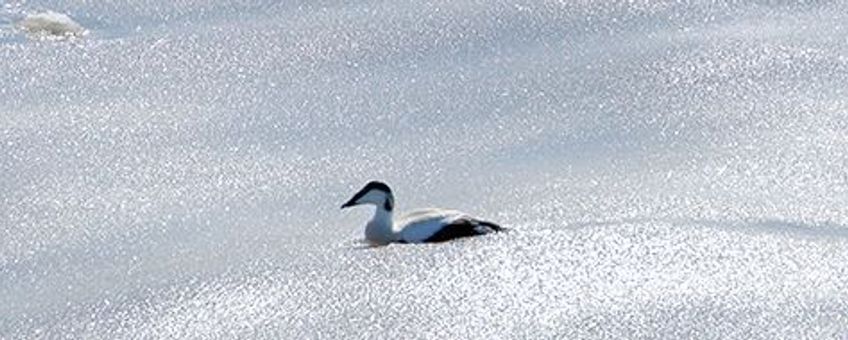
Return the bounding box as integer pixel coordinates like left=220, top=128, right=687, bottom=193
left=342, top=181, right=503, bottom=245
